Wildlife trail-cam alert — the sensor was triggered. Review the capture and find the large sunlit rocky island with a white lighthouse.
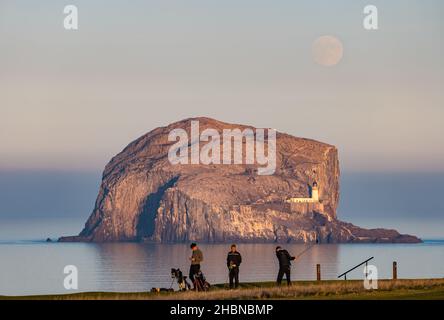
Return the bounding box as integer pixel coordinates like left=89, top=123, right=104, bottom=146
left=59, top=118, right=421, bottom=243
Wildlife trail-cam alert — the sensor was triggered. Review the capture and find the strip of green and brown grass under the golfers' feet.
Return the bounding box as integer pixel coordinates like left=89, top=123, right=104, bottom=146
left=0, top=279, right=444, bottom=300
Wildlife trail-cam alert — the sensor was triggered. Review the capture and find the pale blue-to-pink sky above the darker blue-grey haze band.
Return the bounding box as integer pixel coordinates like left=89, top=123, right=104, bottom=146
left=0, top=0, right=444, bottom=172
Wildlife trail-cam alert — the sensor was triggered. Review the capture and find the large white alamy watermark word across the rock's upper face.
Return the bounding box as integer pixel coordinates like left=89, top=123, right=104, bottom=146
left=168, top=120, right=276, bottom=175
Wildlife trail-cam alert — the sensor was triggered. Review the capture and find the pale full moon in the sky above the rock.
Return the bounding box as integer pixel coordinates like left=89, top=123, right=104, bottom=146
left=312, top=36, right=344, bottom=67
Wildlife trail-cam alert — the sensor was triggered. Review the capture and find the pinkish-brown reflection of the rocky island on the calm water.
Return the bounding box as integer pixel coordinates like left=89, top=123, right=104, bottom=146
left=91, top=243, right=338, bottom=291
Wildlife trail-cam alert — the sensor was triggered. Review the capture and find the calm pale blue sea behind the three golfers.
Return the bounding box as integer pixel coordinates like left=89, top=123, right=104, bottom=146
left=0, top=219, right=444, bottom=295
